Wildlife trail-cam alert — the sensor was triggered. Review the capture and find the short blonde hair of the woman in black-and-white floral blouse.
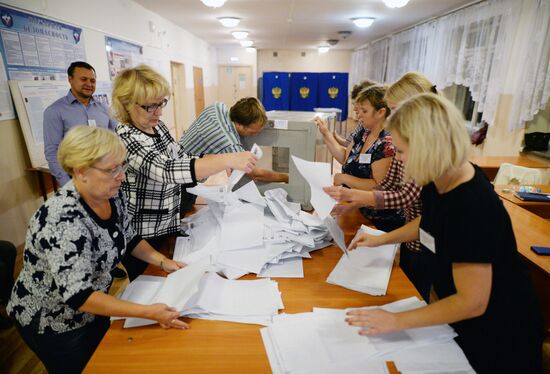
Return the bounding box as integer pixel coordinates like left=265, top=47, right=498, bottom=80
left=57, top=125, right=126, bottom=176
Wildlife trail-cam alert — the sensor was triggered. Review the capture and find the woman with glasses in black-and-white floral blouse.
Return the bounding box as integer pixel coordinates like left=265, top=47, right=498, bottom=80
left=7, top=126, right=188, bottom=373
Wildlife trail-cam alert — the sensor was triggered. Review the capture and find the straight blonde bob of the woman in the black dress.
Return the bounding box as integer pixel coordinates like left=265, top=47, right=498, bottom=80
left=387, top=93, right=471, bottom=186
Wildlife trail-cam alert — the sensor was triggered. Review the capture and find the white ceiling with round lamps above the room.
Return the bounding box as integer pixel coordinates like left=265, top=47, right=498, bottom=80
left=134, top=0, right=473, bottom=49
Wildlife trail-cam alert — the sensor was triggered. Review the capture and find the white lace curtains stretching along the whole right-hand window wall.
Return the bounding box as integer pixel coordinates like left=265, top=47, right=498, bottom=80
left=352, top=0, right=550, bottom=126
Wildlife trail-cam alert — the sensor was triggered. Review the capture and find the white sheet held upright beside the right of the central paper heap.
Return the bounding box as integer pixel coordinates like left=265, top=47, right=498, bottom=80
left=292, top=156, right=336, bottom=218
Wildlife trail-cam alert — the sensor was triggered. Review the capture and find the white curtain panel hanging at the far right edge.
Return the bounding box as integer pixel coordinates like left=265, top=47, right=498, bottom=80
left=509, top=0, right=550, bottom=130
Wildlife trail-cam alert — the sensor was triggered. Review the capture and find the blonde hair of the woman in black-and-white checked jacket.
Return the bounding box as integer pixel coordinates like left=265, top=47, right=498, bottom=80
left=111, top=65, right=170, bottom=124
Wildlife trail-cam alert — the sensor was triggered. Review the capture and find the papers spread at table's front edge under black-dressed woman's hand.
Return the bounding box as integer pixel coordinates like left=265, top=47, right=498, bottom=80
left=261, top=297, right=474, bottom=374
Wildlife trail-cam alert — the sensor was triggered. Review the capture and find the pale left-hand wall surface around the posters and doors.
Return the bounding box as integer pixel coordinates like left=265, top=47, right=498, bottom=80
left=0, top=0, right=218, bottom=245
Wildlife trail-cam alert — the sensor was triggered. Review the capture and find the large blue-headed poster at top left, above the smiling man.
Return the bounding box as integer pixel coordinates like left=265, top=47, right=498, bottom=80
left=0, top=6, right=86, bottom=80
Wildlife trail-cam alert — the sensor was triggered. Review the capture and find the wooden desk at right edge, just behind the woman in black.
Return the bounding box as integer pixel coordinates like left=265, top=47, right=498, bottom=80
left=502, top=199, right=550, bottom=331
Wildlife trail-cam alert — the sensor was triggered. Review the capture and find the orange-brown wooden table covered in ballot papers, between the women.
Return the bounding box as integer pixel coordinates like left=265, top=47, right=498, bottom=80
left=85, top=213, right=420, bottom=373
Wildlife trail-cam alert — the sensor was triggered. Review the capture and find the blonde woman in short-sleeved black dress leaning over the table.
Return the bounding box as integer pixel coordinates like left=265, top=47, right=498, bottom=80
left=347, top=93, right=543, bottom=373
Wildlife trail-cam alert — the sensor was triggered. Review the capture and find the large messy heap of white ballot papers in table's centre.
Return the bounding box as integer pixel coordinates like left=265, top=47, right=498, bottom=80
left=178, top=182, right=330, bottom=279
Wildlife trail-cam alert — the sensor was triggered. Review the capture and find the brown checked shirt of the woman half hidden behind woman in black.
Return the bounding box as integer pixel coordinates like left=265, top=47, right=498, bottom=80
left=374, top=158, right=422, bottom=251
